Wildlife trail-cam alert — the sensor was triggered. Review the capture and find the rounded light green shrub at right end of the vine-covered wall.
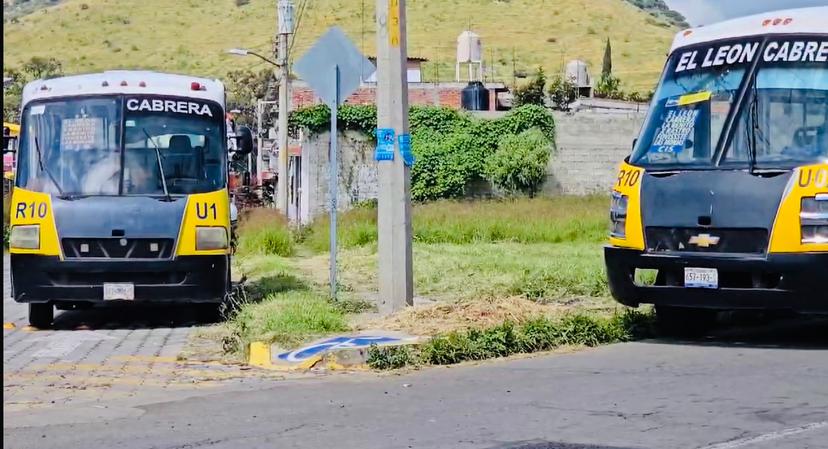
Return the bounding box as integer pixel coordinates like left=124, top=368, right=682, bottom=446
left=486, top=130, right=551, bottom=196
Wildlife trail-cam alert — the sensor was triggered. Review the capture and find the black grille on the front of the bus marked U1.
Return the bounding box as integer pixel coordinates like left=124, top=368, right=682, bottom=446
left=62, top=237, right=174, bottom=259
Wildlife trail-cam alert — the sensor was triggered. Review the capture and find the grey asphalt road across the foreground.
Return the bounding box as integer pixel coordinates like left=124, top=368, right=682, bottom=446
left=4, top=312, right=828, bottom=449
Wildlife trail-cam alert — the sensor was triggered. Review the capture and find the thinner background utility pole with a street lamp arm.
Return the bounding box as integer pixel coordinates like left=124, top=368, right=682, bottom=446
left=276, top=0, right=293, bottom=216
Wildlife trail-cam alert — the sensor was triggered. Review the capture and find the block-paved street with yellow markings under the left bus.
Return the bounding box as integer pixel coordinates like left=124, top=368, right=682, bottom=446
left=3, top=256, right=292, bottom=422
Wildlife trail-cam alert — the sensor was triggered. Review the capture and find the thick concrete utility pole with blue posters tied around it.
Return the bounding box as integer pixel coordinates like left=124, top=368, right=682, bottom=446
left=376, top=0, right=414, bottom=314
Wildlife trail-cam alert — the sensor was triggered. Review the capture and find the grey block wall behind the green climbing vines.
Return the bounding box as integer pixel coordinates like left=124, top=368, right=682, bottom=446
left=301, top=111, right=644, bottom=221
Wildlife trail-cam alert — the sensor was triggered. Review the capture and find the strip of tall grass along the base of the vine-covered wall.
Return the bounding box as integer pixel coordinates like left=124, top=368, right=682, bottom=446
left=305, top=195, right=609, bottom=252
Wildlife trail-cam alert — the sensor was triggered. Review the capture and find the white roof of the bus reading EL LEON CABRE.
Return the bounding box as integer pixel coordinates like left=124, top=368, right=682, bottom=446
left=670, top=6, right=828, bottom=53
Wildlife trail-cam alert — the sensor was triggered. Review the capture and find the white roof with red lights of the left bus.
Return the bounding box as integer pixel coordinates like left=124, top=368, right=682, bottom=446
left=22, top=70, right=224, bottom=108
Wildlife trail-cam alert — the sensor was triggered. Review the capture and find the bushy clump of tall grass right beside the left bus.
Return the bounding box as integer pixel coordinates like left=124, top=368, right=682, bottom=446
left=237, top=208, right=296, bottom=257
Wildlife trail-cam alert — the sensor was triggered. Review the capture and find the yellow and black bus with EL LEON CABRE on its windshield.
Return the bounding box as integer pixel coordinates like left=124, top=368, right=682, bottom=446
left=605, top=7, right=828, bottom=328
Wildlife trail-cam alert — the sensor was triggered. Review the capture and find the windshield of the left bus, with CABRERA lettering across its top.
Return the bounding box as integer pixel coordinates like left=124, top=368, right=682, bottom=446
left=17, top=96, right=227, bottom=196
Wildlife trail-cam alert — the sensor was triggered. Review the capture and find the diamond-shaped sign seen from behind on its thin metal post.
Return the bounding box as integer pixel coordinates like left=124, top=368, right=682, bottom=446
left=293, top=27, right=374, bottom=299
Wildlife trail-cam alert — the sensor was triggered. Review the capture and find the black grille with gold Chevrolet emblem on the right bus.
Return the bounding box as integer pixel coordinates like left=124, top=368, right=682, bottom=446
left=645, top=227, right=768, bottom=254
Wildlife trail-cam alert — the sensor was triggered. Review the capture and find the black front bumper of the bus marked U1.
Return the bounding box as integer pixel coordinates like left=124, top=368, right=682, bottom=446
left=10, top=254, right=229, bottom=303
